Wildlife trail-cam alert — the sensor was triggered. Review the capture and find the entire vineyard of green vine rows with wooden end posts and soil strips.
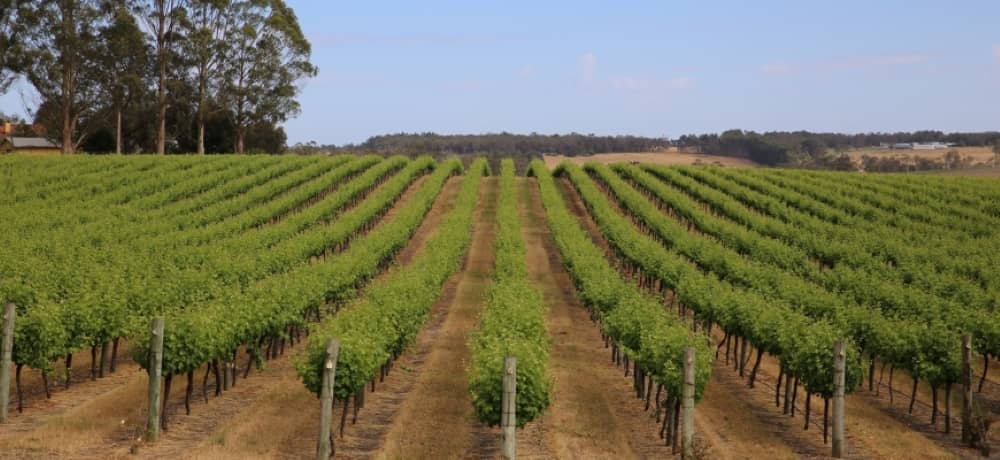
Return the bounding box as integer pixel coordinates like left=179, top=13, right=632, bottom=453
left=0, top=155, right=1000, bottom=459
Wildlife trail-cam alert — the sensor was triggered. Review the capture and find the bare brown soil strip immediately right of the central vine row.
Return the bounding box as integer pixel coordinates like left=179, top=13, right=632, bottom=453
left=517, top=179, right=688, bottom=459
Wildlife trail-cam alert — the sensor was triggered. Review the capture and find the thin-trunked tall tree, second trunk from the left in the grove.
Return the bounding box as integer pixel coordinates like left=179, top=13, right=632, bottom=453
left=97, top=0, right=150, bottom=154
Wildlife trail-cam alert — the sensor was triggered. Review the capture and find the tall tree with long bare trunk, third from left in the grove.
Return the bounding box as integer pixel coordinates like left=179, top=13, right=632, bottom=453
left=139, top=0, right=188, bottom=155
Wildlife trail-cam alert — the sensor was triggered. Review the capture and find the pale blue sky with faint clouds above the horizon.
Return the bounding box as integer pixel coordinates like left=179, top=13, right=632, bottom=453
left=0, top=0, right=1000, bottom=144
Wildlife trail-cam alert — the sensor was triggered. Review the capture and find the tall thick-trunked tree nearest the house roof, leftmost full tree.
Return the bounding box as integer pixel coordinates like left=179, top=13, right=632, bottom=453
left=18, top=0, right=101, bottom=153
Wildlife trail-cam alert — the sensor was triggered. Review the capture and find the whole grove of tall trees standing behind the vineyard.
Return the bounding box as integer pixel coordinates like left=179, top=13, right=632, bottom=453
left=0, top=0, right=318, bottom=153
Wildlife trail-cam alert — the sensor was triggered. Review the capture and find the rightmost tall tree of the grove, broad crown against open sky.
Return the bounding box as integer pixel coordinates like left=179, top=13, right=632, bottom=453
left=220, top=0, right=317, bottom=153
